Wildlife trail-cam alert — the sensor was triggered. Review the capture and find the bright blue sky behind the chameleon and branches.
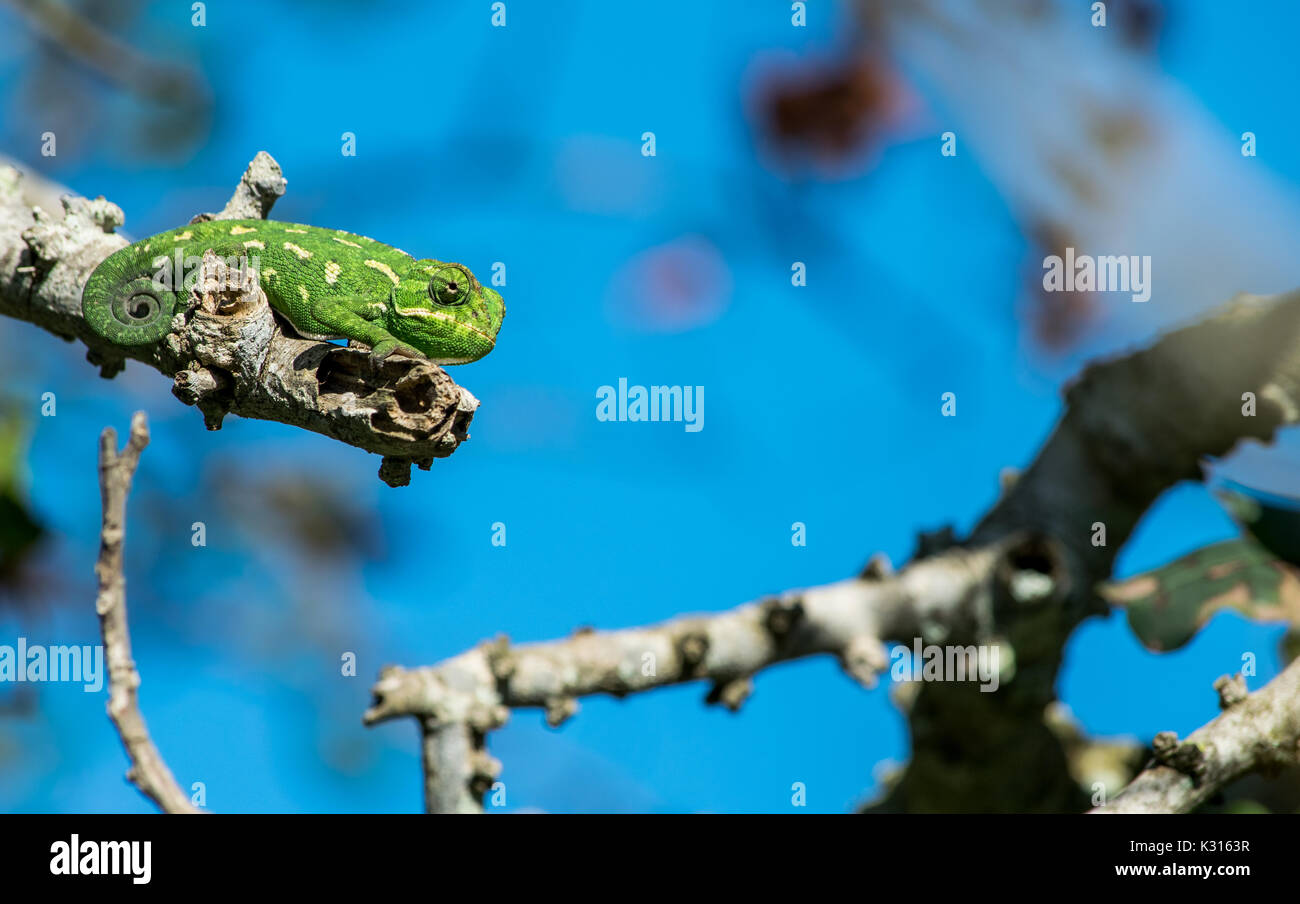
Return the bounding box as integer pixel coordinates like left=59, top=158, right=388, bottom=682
left=0, top=0, right=1300, bottom=812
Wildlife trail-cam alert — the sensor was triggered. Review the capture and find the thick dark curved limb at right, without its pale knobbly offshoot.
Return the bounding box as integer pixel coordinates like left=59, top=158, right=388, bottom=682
left=874, top=293, right=1300, bottom=813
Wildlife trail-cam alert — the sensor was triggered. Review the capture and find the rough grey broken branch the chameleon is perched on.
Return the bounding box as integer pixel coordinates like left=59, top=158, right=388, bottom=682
left=0, top=151, right=478, bottom=486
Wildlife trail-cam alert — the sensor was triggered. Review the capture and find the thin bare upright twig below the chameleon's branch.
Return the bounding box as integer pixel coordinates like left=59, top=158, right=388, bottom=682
left=95, top=411, right=199, bottom=813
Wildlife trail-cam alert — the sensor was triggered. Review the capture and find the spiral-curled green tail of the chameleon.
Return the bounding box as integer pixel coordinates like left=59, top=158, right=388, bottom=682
left=82, top=245, right=181, bottom=345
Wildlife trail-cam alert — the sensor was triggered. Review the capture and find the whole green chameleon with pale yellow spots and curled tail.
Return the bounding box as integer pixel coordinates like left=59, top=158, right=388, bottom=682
left=82, top=220, right=506, bottom=364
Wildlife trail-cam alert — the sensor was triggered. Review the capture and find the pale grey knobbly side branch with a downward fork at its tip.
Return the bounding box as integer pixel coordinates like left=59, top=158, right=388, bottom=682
left=364, top=537, right=1052, bottom=813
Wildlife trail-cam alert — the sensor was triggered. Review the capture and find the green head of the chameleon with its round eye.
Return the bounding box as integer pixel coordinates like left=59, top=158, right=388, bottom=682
left=389, top=259, right=506, bottom=364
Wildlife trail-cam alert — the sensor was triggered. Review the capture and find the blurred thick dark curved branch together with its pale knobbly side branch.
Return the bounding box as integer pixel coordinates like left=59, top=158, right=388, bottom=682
left=364, top=293, right=1300, bottom=812
